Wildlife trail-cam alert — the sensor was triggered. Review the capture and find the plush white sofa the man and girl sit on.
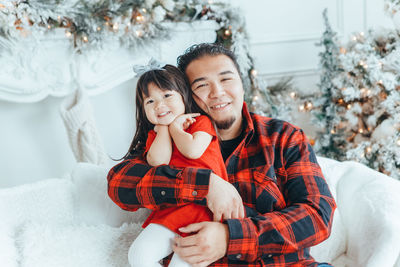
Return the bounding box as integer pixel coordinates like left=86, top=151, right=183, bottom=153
left=0, top=158, right=400, bottom=267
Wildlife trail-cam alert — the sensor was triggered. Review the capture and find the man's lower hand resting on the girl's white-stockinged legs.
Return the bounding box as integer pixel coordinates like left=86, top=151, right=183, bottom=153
left=172, top=222, right=229, bottom=267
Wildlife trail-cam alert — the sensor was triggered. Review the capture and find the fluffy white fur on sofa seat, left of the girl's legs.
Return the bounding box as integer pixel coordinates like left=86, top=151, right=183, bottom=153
left=17, top=223, right=142, bottom=267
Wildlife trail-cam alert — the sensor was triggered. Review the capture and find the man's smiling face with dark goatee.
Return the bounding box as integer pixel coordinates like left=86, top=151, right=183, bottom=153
left=186, top=55, right=244, bottom=138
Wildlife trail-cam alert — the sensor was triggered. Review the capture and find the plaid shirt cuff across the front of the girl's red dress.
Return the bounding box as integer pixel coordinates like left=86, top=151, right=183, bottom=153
left=178, top=168, right=211, bottom=206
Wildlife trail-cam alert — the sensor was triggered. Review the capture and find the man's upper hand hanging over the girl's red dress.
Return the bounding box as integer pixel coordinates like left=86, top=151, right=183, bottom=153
left=206, top=173, right=245, bottom=222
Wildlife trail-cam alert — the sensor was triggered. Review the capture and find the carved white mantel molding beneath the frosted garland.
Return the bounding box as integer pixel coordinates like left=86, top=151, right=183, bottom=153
left=0, top=21, right=219, bottom=102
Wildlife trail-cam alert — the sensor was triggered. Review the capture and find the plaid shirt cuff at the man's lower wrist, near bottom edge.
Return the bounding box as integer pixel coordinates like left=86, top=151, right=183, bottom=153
left=225, top=218, right=258, bottom=262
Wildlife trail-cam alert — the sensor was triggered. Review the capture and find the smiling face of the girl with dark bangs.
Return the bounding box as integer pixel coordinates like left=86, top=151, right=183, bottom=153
left=143, top=83, right=185, bottom=125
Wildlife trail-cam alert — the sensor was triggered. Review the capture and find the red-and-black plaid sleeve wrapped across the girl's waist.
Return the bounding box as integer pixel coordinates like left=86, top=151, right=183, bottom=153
left=107, top=157, right=211, bottom=211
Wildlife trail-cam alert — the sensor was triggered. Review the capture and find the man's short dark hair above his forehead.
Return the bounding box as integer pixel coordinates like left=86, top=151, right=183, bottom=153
left=177, top=43, right=241, bottom=76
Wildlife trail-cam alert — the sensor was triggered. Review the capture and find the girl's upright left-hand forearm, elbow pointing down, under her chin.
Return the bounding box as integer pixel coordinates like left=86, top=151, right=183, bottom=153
left=146, top=125, right=172, bottom=166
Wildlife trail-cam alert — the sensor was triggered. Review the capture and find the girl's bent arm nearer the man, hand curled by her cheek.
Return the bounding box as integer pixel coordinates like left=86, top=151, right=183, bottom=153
left=169, top=114, right=213, bottom=159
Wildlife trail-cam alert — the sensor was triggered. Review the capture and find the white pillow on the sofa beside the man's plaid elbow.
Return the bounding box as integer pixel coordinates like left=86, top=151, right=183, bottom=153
left=71, top=163, right=150, bottom=227
